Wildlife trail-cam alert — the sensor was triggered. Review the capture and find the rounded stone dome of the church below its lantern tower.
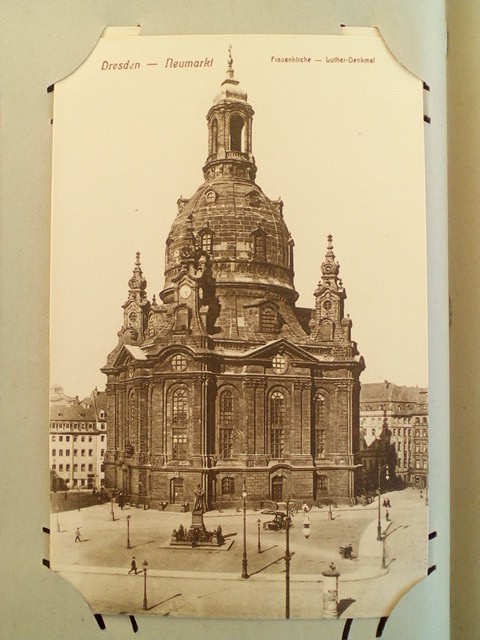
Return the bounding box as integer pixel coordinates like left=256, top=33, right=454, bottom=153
left=165, top=175, right=294, bottom=293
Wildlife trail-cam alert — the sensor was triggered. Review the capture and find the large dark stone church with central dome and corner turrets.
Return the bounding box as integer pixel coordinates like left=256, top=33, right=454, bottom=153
left=102, top=53, right=364, bottom=508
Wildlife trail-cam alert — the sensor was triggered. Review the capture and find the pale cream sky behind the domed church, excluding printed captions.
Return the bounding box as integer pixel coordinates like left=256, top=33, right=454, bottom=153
left=51, top=35, right=427, bottom=396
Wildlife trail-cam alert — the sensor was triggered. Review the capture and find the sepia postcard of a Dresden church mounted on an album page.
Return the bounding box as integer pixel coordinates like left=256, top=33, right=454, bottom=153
left=45, top=29, right=429, bottom=619
